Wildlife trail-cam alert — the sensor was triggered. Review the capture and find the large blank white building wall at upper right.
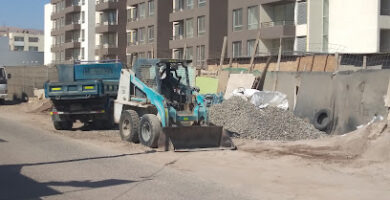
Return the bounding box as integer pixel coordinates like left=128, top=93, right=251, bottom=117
left=329, top=0, right=380, bottom=53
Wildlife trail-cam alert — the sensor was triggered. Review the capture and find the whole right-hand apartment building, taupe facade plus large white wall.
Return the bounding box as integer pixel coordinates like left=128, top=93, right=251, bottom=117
left=228, top=0, right=390, bottom=57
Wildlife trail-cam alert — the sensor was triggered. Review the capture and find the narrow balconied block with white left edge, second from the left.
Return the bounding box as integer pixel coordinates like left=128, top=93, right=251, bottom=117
left=95, top=0, right=127, bottom=63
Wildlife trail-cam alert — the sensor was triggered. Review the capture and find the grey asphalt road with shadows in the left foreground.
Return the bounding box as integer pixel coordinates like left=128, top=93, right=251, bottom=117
left=0, top=116, right=253, bottom=200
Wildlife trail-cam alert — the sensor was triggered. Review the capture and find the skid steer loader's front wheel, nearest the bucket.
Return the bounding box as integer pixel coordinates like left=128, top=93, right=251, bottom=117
left=139, top=114, right=162, bottom=148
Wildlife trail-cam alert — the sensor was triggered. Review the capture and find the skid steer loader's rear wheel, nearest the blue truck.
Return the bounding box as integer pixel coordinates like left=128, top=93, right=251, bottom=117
left=119, top=110, right=139, bottom=143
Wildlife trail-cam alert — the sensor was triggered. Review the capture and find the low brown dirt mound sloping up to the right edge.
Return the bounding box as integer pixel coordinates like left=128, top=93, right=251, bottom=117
left=240, top=122, right=390, bottom=162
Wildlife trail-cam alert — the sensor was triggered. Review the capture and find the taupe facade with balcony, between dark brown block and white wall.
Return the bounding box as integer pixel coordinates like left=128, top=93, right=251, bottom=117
left=227, top=0, right=298, bottom=58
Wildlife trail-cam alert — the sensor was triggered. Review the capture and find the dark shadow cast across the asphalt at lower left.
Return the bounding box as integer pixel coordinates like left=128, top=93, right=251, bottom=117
left=0, top=151, right=156, bottom=200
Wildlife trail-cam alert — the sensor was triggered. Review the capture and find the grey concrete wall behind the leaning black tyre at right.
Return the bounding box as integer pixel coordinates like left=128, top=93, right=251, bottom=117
left=264, top=70, right=390, bottom=134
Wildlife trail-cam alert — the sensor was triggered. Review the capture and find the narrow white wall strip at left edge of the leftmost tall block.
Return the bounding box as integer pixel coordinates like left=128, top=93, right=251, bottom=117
left=44, top=3, right=53, bottom=65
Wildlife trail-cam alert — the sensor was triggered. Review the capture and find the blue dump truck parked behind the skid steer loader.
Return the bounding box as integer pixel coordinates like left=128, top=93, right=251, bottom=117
left=45, top=61, right=122, bottom=130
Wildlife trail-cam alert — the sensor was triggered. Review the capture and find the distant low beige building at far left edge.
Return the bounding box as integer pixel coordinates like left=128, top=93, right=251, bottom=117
left=0, top=26, right=44, bottom=52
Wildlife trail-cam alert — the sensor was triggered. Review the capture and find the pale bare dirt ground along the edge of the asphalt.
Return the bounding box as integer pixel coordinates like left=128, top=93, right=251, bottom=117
left=0, top=100, right=390, bottom=200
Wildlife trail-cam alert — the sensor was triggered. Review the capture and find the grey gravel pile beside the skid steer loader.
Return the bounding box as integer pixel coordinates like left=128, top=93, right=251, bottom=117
left=209, top=97, right=323, bottom=141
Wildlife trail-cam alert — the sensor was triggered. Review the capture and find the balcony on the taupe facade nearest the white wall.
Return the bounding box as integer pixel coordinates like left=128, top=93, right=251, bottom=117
left=260, top=21, right=295, bottom=39
